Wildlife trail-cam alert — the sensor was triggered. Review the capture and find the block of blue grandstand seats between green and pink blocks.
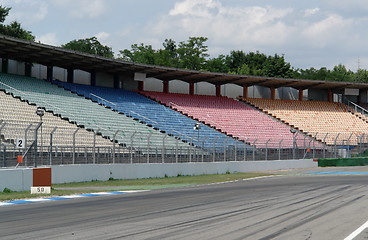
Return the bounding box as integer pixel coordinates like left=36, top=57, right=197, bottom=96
left=53, top=81, right=243, bottom=150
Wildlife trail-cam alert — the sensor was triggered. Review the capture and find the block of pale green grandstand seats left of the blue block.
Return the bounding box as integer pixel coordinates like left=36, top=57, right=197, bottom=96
left=0, top=73, right=197, bottom=156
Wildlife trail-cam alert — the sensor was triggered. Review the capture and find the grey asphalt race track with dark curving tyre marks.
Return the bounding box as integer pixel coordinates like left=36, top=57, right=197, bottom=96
left=0, top=172, right=368, bottom=240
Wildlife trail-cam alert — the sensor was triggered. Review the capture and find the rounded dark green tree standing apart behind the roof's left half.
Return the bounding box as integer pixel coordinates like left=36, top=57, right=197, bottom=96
left=61, top=37, right=114, bottom=58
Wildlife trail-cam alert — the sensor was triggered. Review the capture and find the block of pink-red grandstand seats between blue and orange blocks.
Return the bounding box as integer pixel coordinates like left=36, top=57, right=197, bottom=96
left=138, top=92, right=316, bottom=148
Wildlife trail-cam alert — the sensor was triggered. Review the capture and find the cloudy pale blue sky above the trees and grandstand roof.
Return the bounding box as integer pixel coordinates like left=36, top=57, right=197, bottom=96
left=0, top=0, right=368, bottom=71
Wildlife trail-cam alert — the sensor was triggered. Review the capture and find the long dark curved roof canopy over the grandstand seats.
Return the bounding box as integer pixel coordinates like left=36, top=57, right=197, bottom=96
left=0, top=35, right=368, bottom=89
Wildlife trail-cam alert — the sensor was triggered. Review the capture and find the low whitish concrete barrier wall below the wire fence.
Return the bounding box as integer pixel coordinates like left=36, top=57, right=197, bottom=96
left=0, top=159, right=318, bottom=191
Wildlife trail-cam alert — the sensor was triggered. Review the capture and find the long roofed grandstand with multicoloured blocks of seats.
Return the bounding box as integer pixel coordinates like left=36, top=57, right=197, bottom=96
left=0, top=36, right=368, bottom=165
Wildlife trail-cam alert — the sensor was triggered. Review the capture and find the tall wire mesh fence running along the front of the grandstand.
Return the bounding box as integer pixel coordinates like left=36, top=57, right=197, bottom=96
left=0, top=121, right=368, bottom=167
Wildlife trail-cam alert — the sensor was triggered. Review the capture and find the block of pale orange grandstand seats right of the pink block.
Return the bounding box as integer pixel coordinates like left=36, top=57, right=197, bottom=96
left=241, top=98, right=368, bottom=145
